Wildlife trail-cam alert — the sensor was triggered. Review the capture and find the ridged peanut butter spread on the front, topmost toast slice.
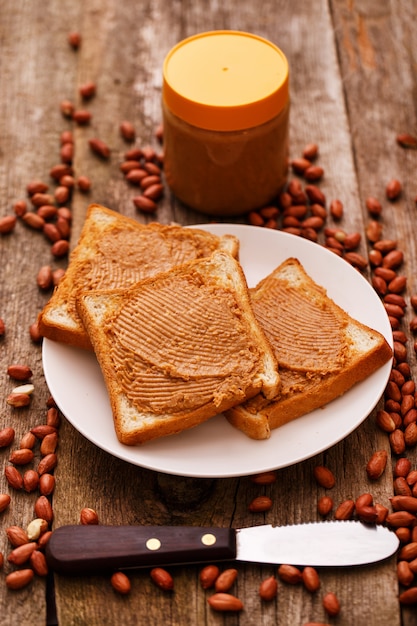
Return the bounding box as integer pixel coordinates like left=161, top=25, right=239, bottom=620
left=105, top=274, right=260, bottom=414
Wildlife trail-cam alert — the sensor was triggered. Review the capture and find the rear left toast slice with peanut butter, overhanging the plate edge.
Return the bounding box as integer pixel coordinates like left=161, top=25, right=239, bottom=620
left=38, top=204, right=239, bottom=350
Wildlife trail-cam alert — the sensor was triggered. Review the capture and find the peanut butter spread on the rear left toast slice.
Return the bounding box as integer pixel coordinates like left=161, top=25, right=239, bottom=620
left=69, top=224, right=224, bottom=317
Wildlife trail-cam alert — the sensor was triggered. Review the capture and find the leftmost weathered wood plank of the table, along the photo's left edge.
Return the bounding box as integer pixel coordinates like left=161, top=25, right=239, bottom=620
left=0, top=0, right=81, bottom=625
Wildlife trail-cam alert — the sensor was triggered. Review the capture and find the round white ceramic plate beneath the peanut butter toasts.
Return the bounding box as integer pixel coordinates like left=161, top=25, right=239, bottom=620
left=43, top=224, right=392, bottom=478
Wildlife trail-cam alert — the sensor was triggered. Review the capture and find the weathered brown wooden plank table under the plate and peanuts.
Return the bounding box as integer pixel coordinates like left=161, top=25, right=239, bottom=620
left=0, top=0, right=417, bottom=626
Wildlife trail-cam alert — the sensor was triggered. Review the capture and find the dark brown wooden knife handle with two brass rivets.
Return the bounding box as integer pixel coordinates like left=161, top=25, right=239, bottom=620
left=46, top=525, right=236, bottom=575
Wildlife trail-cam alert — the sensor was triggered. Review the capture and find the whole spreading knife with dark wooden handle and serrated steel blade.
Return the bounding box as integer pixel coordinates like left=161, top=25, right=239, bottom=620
left=46, top=521, right=399, bottom=574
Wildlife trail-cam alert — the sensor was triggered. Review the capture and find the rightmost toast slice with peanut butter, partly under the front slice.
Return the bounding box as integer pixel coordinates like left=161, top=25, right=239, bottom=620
left=226, top=258, right=392, bottom=439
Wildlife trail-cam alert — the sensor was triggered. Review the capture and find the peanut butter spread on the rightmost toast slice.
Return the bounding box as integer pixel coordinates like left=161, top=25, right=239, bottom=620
left=252, top=278, right=347, bottom=370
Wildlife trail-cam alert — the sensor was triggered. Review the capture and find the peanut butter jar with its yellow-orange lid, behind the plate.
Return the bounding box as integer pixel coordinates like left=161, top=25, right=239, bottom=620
left=162, top=30, right=289, bottom=216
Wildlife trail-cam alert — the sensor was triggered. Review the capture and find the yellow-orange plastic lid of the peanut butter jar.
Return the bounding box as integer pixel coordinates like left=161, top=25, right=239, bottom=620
left=162, top=30, right=289, bottom=131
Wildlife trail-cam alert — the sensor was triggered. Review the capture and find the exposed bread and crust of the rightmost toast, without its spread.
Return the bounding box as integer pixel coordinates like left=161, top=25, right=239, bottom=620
left=226, top=259, right=392, bottom=439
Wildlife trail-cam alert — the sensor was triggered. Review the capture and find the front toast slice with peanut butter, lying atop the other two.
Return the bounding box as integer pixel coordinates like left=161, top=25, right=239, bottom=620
left=77, top=251, right=279, bottom=445
